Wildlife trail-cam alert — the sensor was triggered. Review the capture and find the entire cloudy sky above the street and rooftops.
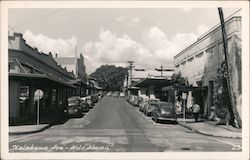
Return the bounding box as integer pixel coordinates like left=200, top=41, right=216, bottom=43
left=8, top=8, right=239, bottom=74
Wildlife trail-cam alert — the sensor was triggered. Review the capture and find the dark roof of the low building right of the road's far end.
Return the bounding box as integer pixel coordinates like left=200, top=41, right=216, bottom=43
left=134, top=78, right=171, bottom=87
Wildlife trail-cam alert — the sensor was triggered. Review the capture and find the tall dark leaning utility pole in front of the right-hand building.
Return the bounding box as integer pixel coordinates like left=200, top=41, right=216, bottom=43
left=218, top=7, right=242, bottom=127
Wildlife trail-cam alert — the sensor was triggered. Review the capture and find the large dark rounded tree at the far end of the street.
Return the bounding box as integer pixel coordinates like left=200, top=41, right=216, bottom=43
left=90, top=65, right=128, bottom=91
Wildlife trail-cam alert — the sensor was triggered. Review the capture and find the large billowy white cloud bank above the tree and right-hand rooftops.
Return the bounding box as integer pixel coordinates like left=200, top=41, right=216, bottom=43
left=84, top=25, right=206, bottom=73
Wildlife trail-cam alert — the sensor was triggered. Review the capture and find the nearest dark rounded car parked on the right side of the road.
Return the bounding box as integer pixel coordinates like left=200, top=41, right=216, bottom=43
left=151, top=102, right=177, bottom=123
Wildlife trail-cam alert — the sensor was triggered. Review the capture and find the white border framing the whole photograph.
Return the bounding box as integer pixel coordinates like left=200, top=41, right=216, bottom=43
left=0, top=1, right=249, bottom=160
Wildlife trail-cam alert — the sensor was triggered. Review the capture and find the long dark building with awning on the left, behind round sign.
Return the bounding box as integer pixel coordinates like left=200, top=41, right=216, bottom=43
left=8, top=33, right=76, bottom=125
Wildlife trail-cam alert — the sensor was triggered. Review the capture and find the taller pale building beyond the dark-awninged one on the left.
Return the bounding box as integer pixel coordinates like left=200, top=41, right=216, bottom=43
left=54, top=54, right=87, bottom=97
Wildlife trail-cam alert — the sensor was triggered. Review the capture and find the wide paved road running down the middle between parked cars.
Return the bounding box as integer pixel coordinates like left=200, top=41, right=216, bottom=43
left=9, top=97, right=241, bottom=152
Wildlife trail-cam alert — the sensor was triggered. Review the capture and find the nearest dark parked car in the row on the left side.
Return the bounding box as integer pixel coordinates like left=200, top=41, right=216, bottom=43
left=65, top=97, right=83, bottom=116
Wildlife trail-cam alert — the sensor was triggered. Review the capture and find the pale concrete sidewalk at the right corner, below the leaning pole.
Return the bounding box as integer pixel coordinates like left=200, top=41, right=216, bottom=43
left=178, top=119, right=242, bottom=139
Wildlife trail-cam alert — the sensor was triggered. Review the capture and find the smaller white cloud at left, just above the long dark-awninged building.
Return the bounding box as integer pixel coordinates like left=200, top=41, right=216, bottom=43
left=23, top=30, right=77, bottom=57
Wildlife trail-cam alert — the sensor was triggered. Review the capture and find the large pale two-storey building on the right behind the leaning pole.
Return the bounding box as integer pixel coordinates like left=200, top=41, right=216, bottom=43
left=174, top=16, right=242, bottom=117
